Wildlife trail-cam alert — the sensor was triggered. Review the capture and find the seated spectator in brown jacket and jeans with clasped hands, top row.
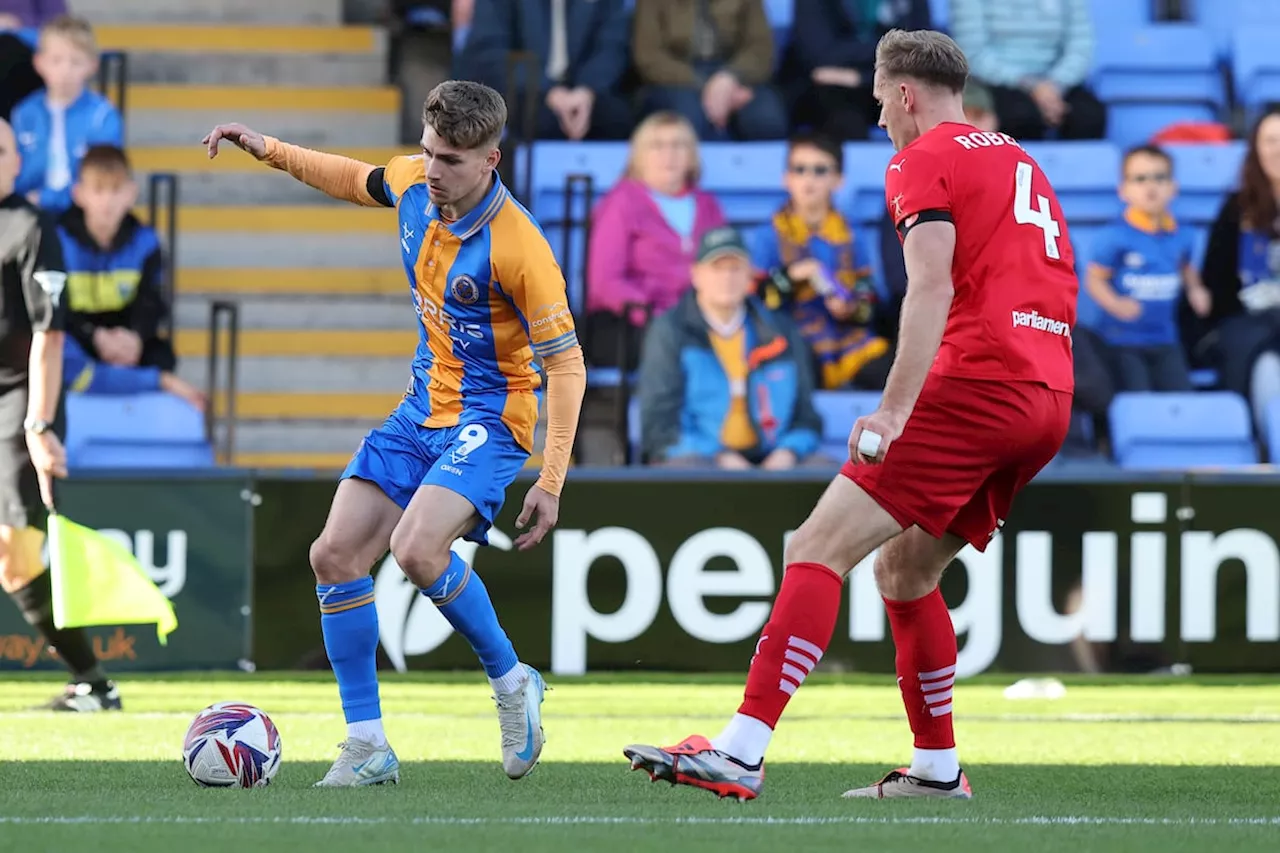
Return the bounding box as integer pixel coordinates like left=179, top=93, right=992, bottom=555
left=632, top=0, right=787, bottom=140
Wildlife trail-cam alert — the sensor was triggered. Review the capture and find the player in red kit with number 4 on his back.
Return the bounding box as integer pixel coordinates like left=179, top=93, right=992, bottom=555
left=623, top=29, right=1078, bottom=799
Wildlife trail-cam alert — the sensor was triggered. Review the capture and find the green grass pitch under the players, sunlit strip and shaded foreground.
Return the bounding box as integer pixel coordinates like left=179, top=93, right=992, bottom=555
left=0, top=674, right=1280, bottom=853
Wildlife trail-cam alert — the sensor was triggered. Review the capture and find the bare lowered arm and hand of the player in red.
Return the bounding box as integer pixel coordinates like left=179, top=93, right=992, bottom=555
left=849, top=220, right=956, bottom=461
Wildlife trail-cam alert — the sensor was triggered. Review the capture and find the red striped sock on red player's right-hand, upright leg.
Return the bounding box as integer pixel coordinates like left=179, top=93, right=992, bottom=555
left=884, top=589, right=960, bottom=783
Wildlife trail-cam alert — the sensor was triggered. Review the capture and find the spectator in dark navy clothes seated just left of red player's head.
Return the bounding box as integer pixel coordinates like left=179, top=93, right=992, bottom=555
left=780, top=0, right=931, bottom=142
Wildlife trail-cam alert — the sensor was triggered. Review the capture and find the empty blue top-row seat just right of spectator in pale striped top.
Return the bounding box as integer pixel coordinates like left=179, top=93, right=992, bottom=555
left=1093, top=23, right=1226, bottom=147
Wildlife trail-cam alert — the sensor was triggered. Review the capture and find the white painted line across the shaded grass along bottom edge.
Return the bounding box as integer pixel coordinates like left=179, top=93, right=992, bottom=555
left=0, top=815, right=1280, bottom=826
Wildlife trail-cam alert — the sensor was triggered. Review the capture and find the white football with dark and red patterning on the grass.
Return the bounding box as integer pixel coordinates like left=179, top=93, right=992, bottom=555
left=182, top=702, right=280, bottom=788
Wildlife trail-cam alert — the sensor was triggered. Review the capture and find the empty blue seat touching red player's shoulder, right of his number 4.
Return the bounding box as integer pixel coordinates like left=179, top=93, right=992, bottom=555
left=1010, top=141, right=1123, bottom=227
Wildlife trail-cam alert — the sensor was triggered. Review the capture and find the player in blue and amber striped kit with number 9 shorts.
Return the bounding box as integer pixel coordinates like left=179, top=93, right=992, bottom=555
left=205, top=81, right=586, bottom=788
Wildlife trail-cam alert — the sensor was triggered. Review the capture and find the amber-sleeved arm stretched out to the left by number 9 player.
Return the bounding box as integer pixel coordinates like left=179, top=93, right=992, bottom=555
left=202, top=123, right=390, bottom=207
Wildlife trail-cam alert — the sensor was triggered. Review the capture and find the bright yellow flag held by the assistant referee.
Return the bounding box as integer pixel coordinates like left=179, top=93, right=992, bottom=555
left=49, top=514, right=178, bottom=646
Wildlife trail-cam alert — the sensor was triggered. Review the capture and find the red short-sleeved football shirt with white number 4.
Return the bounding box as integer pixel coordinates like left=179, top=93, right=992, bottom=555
left=884, top=122, right=1079, bottom=391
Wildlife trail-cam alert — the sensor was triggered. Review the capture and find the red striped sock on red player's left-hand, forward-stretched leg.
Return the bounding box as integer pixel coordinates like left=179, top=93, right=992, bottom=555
left=712, top=562, right=844, bottom=765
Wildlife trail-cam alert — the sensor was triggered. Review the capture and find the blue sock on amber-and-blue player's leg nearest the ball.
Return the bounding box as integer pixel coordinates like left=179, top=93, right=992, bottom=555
left=316, top=578, right=383, bottom=722
